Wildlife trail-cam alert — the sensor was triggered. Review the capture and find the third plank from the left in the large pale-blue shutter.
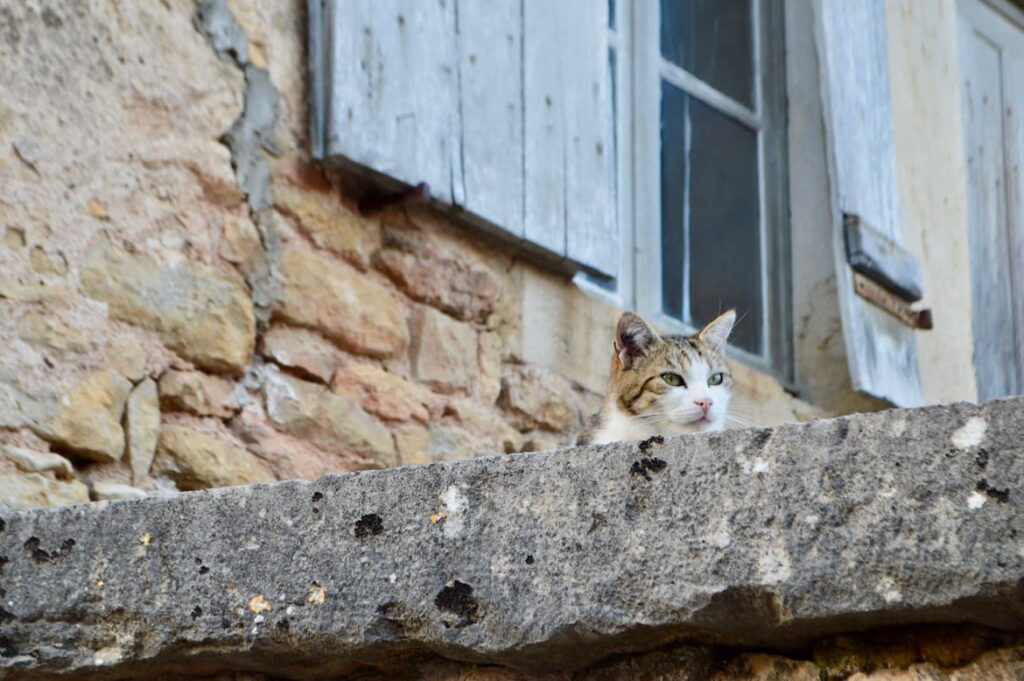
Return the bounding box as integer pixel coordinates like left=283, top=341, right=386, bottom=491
left=522, top=0, right=571, bottom=255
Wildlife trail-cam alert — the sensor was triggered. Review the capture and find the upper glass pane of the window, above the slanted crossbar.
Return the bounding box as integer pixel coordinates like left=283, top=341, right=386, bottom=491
left=662, top=0, right=754, bottom=109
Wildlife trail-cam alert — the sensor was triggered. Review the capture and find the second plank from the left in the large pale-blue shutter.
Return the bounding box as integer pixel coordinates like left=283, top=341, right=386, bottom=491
left=458, top=0, right=523, bottom=237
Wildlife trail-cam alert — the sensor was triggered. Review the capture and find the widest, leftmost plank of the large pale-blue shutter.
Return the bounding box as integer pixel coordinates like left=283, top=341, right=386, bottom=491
left=325, top=0, right=461, bottom=202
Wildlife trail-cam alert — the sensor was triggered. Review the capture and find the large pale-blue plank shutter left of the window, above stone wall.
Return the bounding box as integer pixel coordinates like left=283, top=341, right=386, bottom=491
left=308, top=0, right=618, bottom=275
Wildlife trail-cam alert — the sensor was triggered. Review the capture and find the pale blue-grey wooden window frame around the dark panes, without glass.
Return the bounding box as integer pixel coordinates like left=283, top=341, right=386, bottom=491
left=577, top=0, right=795, bottom=386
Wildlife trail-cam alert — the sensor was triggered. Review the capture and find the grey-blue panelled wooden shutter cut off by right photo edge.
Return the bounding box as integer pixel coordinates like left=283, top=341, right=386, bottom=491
left=959, top=0, right=1024, bottom=399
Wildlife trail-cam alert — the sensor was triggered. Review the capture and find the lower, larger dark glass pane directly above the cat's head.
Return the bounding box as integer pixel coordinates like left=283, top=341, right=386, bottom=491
left=662, top=82, right=764, bottom=354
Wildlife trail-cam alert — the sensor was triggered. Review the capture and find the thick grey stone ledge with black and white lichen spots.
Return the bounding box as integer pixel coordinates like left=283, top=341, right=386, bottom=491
left=0, top=398, right=1024, bottom=679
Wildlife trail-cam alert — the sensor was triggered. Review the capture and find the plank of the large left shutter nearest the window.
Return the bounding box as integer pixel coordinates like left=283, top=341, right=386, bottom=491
left=559, top=0, right=618, bottom=275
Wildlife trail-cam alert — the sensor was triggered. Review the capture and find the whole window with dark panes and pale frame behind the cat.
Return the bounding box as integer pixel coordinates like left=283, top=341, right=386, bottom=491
left=585, top=0, right=792, bottom=378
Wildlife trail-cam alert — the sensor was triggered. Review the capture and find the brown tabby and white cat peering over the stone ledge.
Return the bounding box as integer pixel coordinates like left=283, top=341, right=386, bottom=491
left=577, top=310, right=736, bottom=444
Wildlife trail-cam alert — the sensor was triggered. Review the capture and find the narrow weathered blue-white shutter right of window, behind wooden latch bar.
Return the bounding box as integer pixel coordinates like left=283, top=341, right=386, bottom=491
left=815, top=0, right=922, bottom=407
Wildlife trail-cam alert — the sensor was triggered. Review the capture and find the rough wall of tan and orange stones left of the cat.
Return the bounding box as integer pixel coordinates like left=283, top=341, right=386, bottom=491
left=0, top=0, right=606, bottom=507
